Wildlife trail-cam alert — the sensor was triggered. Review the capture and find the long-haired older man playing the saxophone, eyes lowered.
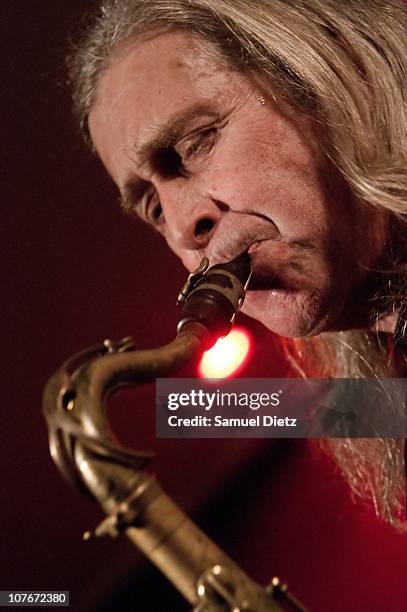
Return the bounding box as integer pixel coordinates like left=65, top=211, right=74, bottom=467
left=70, top=0, right=407, bottom=525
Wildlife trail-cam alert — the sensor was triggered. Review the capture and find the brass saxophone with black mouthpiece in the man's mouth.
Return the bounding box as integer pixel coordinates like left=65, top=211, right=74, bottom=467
left=43, top=253, right=304, bottom=612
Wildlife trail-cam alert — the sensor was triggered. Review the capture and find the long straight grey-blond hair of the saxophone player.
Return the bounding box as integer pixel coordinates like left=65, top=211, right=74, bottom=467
left=69, top=0, right=407, bottom=526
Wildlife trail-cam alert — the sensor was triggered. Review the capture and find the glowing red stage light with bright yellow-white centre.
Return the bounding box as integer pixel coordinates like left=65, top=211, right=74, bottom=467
left=198, top=327, right=252, bottom=378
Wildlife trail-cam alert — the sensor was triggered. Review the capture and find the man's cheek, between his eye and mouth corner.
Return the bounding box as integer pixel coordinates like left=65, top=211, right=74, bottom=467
left=206, top=134, right=328, bottom=238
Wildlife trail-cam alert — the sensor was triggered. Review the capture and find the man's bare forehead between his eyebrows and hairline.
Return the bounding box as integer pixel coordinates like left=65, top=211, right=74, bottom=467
left=89, top=32, right=237, bottom=179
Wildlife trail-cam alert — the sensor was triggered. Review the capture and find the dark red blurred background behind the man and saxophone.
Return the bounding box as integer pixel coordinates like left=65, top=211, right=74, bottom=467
left=0, top=0, right=407, bottom=612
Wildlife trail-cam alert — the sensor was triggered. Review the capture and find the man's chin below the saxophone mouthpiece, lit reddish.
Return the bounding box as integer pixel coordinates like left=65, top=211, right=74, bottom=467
left=242, top=289, right=332, bottom=338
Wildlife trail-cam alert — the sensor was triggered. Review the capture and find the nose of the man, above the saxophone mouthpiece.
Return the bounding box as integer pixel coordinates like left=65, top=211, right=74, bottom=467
left=160, top=180, right=224, bottom=250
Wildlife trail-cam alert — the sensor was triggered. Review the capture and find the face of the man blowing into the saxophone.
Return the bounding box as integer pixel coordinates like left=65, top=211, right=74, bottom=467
left=89, top=32, right=386, bottom=336
